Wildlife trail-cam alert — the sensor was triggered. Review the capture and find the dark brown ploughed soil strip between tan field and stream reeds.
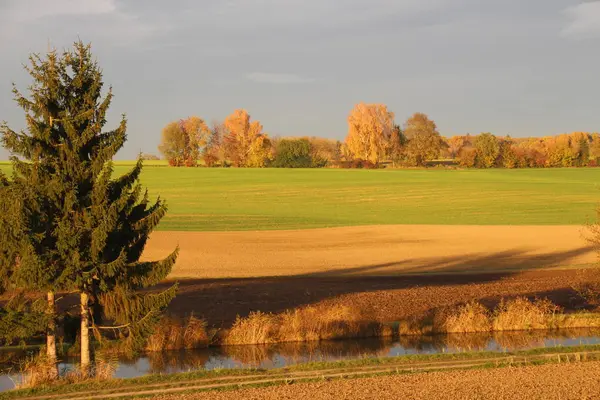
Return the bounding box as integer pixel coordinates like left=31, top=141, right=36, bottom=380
left=162, top=269, right=600, bottom=328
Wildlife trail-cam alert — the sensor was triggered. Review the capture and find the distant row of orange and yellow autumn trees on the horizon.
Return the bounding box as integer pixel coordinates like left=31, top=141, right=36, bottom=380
left=157, top=103, right=600, bottom=168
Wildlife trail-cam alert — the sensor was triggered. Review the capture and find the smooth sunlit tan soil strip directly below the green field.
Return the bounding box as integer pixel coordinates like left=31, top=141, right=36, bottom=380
left=145, top=225, right=596, bottom=278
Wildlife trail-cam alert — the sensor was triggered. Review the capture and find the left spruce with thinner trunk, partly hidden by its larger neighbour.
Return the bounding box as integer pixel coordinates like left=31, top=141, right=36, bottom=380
left=0, top=52, right=65, bottom=377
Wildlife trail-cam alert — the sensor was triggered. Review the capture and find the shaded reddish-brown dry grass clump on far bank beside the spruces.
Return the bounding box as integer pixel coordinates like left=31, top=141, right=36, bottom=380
left=146, top=315, right=210, bottom=351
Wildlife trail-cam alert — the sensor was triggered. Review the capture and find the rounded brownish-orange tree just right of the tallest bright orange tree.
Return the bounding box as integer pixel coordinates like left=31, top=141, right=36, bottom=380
left=404, top=113, right=443, bottom=166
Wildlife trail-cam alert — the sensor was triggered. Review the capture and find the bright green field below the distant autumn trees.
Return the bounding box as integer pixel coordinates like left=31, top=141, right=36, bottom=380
left=0, top=163, right=600, bottom=231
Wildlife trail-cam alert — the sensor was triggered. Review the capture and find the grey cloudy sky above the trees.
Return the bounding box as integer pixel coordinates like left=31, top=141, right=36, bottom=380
left=0, top=0, right=600, bottom=159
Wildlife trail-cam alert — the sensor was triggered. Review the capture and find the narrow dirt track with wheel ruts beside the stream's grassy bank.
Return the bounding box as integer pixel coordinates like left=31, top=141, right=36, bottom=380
left=18, top=352, right=600, bottom=400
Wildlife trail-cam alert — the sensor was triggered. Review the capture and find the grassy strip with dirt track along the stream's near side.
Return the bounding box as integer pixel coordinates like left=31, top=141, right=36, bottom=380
left=7, top=346, right=600, bottom=400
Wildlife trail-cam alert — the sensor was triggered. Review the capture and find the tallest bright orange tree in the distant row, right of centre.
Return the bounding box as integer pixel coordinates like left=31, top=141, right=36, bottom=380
left=346, top=103, right=395, bottom=164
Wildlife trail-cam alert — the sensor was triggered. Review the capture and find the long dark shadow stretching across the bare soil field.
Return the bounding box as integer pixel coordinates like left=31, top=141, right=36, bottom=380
left=163, top=246, right=592, bottom=326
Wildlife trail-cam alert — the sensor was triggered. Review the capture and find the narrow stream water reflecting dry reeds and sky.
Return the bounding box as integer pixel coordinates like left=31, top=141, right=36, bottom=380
left=0, top=329, right=600, bottom=390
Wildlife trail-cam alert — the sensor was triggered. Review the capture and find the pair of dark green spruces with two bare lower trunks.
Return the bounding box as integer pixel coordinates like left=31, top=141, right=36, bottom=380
left=0, top=42, right=178, bottom=378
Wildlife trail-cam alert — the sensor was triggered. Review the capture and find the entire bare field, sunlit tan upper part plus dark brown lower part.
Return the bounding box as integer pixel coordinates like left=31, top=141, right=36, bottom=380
left=141, top=226, right=597, bottom=327
